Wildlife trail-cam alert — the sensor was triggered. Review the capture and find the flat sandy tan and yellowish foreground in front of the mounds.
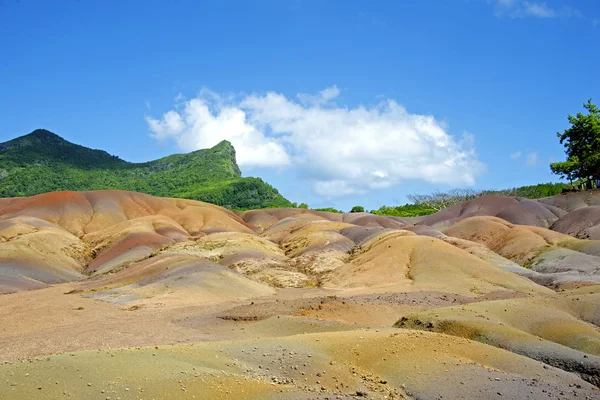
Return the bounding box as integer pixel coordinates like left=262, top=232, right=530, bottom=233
left=0, top=283, right=600, bottom=399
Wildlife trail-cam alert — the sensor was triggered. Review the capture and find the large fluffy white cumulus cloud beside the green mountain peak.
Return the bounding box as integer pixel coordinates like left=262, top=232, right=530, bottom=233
left=147, top=86, right=483, bottom=197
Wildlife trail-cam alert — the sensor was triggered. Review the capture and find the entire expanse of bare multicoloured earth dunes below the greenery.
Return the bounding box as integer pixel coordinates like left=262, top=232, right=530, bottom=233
left=0, top=191, right=600, bottom=399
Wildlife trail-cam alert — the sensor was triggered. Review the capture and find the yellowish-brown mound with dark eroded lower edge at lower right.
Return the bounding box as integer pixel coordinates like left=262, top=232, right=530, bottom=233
left=396, top=298, right=600, bottom=385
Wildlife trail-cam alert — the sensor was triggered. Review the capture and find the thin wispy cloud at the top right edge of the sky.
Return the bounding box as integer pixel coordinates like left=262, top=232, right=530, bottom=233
left=488, top=0, right=582, bottom=19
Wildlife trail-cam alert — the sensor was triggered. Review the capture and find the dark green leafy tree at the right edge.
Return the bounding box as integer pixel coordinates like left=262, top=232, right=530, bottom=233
left=550, top=99, right=600, bottom=188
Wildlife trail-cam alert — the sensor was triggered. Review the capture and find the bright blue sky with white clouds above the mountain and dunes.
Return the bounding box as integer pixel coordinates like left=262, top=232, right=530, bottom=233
left=0, top=0, right=600, bottom=209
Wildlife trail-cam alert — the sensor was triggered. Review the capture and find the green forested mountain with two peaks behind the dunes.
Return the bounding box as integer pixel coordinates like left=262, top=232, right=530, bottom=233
left=0, top=129, right=291, bottom=209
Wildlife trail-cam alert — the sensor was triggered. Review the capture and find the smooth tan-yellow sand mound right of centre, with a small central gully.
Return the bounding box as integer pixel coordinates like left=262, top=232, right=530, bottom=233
left=325, top=231, right=549, bottom=296
